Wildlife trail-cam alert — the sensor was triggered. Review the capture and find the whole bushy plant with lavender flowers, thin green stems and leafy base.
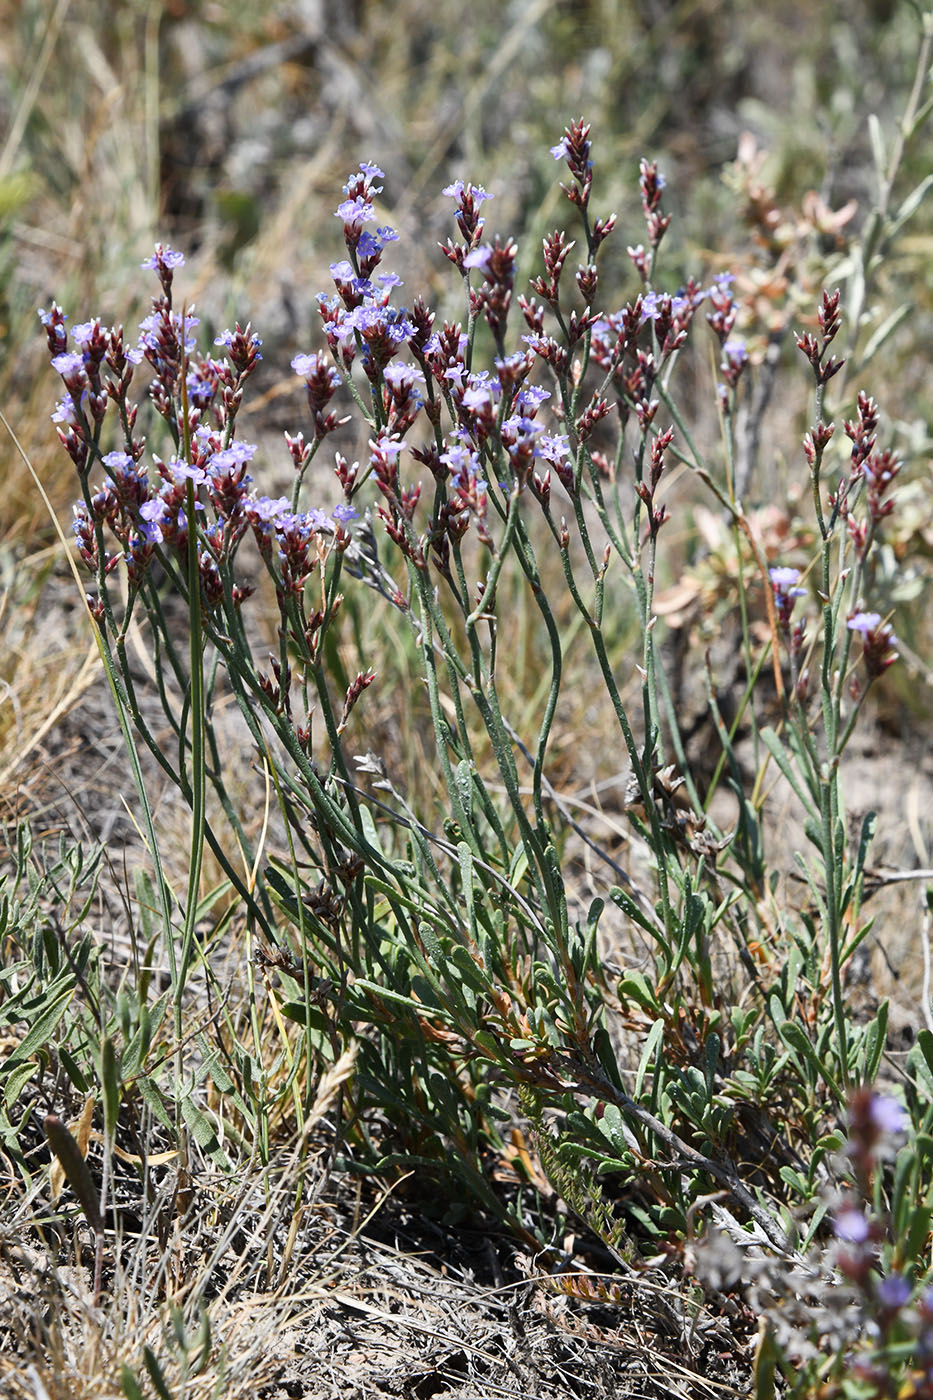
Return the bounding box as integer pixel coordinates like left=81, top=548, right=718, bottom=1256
left=42, top=112, right=918, bottom=1282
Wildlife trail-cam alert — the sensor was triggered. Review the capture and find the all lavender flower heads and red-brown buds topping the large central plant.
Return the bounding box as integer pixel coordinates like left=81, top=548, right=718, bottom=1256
left=41, top=139, right=898, bottom=744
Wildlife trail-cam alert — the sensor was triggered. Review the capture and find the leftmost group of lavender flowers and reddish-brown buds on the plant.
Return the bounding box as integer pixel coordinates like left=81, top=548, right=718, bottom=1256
left=39, top=244, right=356, bottom=620
